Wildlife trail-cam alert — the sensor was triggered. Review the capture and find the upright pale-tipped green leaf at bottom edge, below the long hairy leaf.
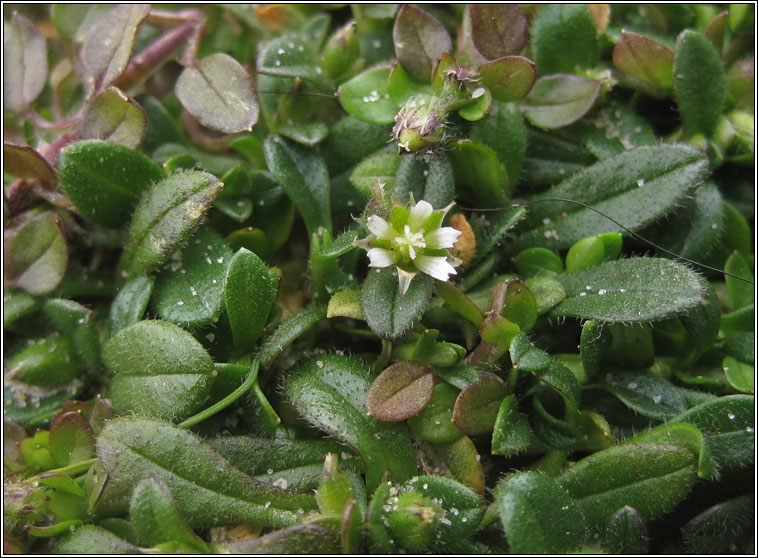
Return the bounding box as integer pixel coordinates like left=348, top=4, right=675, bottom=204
left=129, top=475, right=208, bottom=554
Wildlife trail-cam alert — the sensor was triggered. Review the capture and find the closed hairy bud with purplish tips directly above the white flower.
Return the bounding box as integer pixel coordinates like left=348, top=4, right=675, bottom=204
left=392, top=98, right=447, bottom=153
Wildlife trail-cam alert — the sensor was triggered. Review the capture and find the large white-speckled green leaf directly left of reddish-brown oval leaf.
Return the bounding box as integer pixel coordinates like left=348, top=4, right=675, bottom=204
left=284, top=355, right=417, bottom=491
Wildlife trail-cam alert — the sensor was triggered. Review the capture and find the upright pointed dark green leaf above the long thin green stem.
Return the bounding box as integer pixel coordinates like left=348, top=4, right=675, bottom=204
left=224, top=248, right=276, bottom=353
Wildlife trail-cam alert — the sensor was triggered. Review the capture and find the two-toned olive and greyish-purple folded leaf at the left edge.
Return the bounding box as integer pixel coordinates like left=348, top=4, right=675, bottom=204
left=5, top=211, right=68, bottom=295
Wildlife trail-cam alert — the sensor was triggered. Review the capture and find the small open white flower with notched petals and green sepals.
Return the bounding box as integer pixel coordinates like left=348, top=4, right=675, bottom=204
left=358, top=200, right=461, bottom=294
